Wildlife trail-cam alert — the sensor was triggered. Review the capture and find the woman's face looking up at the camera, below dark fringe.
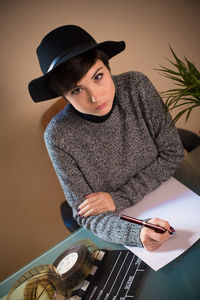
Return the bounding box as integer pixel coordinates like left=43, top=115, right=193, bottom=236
left=64, top=60, right=115, bottom=116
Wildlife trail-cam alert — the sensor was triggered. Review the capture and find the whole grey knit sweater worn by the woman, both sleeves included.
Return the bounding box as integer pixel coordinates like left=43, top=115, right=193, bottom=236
left=45, top=72, right=183, bottom=246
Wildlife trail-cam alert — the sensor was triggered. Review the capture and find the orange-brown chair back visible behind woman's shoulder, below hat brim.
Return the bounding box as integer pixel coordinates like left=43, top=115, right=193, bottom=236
left=41, top=98, right=68, bottom=131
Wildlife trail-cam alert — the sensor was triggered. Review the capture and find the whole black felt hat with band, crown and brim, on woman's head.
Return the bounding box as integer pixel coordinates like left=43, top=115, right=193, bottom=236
left=28, top=25, right=125, bottom=102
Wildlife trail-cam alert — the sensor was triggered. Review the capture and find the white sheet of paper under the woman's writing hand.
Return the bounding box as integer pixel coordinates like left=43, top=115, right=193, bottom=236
left=121, top=178, right=200, bottom=271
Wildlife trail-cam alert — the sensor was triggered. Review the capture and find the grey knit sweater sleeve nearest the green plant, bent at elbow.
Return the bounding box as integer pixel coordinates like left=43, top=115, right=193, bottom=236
left=111, top=73, right=184, bottom=211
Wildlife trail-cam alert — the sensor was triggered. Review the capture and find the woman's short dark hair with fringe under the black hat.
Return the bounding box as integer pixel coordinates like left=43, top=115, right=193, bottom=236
left=49, top=48, right=110, bottom=96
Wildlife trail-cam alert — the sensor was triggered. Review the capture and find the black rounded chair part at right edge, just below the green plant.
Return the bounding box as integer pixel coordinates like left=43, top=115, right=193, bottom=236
left=178, top=128, right=200, bottom=152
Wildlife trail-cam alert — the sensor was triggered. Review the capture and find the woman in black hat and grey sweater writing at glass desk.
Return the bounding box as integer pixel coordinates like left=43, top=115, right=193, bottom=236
left=29, top=25, right=183, bottom=251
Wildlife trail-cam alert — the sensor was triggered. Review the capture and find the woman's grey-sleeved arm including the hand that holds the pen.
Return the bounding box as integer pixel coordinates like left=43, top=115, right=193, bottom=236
left=46, top=135, right=172, bottom=251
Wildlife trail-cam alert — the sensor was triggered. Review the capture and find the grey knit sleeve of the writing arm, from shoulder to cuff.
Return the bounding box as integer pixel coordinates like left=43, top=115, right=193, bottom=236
left=45, top=131, right=142, bottom=247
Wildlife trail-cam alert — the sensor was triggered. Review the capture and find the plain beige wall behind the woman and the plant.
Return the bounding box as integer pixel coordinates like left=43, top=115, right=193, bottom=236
left=0, top=0, right=200, bottom=280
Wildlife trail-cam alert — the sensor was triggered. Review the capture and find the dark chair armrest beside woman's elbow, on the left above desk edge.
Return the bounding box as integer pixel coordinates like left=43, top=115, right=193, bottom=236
left=60, top=201, right=80, bottom=232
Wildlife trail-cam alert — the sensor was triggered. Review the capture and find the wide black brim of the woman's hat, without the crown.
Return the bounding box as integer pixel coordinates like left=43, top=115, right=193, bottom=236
left=28, top=41, right=126, bottom=102
